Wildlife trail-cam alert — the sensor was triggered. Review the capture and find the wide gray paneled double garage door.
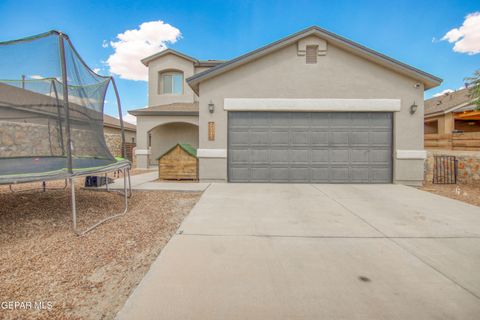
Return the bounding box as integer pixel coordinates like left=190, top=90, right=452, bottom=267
left=228, top=112, right=392, bottom=183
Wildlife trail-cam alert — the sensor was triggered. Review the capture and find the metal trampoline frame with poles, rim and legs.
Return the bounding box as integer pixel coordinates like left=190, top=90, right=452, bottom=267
left=0, top=30, right=132, bottom=236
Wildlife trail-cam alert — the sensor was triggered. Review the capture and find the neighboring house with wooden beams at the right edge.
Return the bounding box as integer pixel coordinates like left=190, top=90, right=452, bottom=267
left=424, top=88, right=480, bottom=150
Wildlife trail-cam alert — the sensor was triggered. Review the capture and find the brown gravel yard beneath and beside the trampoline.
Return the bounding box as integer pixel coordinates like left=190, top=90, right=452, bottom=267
left=0, top=179, right=200, bottom=319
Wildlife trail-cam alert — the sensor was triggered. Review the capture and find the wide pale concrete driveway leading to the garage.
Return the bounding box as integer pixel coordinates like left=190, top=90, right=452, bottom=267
left=118, top=184, right=480, bottom=320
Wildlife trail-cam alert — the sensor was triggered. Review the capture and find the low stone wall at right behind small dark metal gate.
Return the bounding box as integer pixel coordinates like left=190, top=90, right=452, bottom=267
left=425, top=150, right=480, bottom=184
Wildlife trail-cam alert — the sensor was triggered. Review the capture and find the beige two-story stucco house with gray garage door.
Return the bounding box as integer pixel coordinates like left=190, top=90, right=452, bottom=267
left=130, top=27, right=442, bottom=185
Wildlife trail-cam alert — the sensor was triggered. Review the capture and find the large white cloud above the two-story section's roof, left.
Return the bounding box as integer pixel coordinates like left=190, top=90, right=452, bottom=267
left=106, top=20, right=181, bottom=81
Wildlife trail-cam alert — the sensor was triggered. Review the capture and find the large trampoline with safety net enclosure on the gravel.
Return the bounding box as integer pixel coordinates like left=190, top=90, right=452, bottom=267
left=0, top=31, right=131, bottom=235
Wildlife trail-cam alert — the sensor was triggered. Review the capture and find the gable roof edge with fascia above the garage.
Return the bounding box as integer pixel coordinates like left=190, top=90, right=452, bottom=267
left=187, top=26, right=443, bottom=93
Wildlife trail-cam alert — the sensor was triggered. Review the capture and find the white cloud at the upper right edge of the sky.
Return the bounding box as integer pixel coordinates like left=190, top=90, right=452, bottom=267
left=442, top=12, right=480, bottom=55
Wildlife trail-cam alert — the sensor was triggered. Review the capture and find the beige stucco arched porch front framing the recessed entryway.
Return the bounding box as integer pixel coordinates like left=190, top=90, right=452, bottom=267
left=136, top=116, right=198, bottom=168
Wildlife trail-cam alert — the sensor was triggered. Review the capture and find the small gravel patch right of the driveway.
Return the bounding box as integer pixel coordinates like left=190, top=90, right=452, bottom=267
left=420, top=183, right=480, bottom=206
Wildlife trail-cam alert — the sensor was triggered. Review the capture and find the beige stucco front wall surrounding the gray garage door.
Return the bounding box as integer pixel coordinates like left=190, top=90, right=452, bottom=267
left=199, top=38, right=424, bottom=184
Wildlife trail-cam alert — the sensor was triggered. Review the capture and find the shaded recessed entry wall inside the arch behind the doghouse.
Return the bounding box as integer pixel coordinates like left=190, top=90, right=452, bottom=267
left=149, top=123, right=198, bottom=165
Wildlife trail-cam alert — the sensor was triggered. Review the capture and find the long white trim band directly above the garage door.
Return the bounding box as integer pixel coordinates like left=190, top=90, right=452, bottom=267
left=223, top=98, right=401, bottom=112
